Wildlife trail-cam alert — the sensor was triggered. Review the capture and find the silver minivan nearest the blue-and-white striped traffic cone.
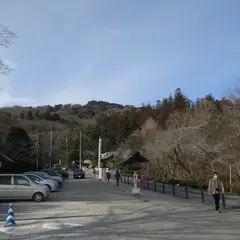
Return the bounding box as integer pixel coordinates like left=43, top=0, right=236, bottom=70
left=0, top=174, right=50, bottom=202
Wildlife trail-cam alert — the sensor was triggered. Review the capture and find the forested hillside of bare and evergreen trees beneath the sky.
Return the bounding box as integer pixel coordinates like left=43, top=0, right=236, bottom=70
left=0, top=88, right=240, bottom=187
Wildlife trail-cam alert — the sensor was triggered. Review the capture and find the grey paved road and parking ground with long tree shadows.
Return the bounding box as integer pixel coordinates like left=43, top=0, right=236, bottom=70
left=0, top=179, right=240, bottom=240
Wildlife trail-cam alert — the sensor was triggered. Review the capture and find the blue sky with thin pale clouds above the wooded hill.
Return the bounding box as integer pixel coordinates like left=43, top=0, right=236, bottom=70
left=0, top=0, right=240, bottom=106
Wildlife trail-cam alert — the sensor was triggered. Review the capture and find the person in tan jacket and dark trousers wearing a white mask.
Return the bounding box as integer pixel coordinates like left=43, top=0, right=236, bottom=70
left=208, top=172, right=224, bottom=213
